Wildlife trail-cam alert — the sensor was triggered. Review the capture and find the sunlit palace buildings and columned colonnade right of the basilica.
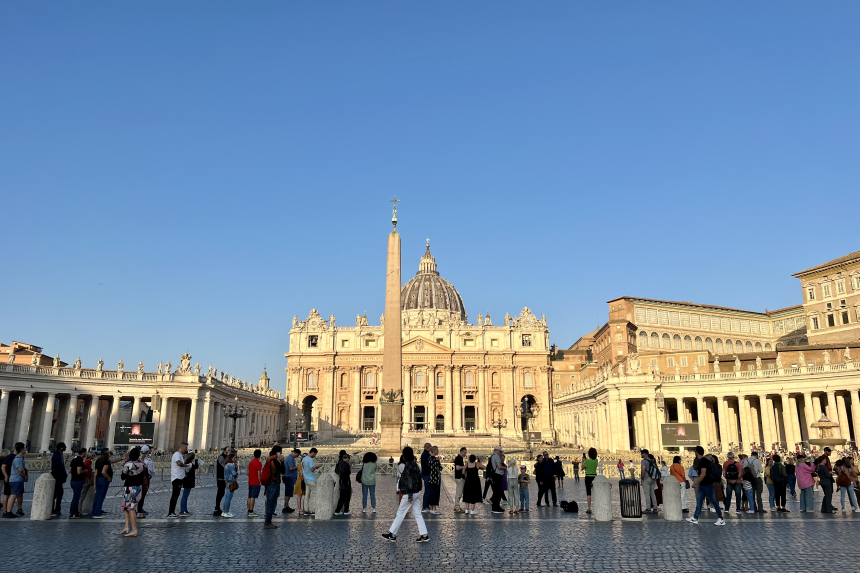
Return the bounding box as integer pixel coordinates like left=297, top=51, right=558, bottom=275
left=552, top=251, right=860, bottom=451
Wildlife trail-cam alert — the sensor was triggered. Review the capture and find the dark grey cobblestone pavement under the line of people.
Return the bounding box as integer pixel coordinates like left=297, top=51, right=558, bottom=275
left=0, top=476, right=860, bottom=573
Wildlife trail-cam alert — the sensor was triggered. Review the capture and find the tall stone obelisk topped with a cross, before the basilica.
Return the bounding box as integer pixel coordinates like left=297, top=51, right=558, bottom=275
left=379, top=197, right=403, bottom=457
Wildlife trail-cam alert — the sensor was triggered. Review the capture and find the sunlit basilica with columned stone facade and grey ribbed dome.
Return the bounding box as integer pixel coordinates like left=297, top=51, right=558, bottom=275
left=285, top=243, right=553, bottom=438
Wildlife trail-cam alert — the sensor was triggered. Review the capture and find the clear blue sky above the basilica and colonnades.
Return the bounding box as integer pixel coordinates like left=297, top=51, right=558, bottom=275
left=0, top=1, right=860, bottom=396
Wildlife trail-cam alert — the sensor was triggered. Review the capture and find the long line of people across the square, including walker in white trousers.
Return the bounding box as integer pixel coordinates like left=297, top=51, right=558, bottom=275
left=6, top=442, right=860, bottom=542
